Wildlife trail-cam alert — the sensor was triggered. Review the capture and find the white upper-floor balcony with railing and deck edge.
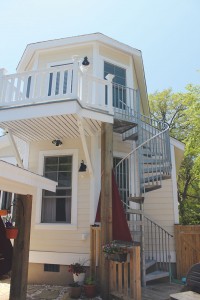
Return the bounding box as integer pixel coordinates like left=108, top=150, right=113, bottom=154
left=0, top=62, right=139, bottom=140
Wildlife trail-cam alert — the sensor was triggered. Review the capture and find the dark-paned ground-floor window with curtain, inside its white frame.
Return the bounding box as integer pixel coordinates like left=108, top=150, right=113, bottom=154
left=41, top=155, right=72, bottom=223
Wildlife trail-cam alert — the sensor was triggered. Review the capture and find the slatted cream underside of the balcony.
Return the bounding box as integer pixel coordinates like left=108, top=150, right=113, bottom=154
left=0, top=114, right=101, bottom=142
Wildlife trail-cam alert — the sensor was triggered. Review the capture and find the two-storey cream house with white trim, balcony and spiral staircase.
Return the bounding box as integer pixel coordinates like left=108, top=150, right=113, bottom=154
left=0, top=33, right=184, bottom=284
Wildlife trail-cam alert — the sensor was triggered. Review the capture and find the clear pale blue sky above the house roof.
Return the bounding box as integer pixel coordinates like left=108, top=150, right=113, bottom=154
left=0, top=0, right=200, bottom=93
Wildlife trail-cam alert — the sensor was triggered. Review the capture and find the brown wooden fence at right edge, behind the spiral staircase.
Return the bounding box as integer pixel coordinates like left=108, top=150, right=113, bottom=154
left=175, top=225, right=200, bottom=279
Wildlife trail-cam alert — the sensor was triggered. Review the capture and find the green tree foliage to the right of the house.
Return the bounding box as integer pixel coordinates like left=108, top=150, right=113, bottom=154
left=149, top=84, right=200, bottom=224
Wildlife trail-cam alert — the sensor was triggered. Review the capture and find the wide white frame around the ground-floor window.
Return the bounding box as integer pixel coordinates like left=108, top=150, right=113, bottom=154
left=35, top=149, right=78, bottom=230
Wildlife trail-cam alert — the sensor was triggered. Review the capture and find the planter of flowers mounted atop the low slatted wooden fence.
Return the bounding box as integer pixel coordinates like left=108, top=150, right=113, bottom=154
left=103, top=241, right=127, bottom=262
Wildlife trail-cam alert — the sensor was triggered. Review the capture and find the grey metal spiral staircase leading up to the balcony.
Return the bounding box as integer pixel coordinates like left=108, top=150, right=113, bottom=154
left=113, top=97, right=172, bottom=286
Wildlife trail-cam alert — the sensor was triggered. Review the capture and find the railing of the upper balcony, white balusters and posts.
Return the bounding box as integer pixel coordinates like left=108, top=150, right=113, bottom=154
left=0, top=62, right=137, bottom=114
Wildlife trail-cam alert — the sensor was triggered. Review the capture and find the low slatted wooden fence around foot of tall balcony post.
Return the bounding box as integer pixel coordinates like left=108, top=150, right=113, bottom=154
left=90, top=226, right=141, bottom=300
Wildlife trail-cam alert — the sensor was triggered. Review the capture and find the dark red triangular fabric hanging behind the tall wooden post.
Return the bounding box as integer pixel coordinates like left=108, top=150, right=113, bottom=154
left=95, top=173, right=132, bottom=242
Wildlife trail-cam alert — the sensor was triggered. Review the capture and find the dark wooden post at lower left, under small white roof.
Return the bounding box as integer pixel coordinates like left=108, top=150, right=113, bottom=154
left=10, top=195, right=32, bottom=300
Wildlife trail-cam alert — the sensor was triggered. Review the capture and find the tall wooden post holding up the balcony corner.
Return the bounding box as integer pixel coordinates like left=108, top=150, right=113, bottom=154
left=100, top=123, right=113, bottom=299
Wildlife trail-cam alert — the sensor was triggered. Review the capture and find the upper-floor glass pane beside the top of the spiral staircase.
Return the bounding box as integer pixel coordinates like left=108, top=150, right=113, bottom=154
left=104, top=62, right=126, bottom=109
